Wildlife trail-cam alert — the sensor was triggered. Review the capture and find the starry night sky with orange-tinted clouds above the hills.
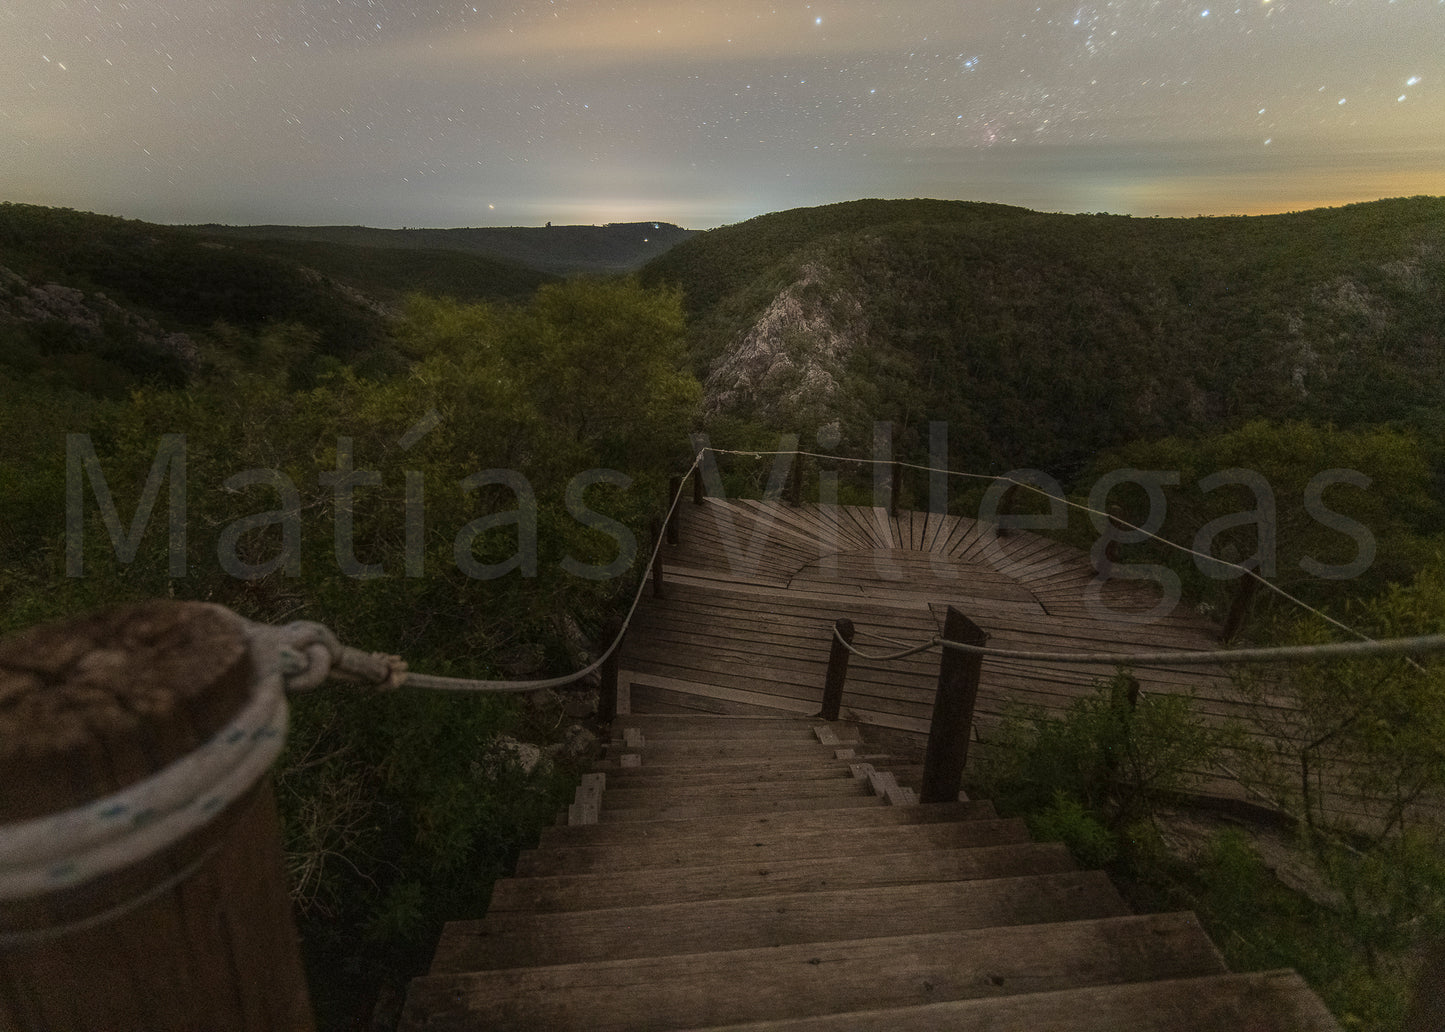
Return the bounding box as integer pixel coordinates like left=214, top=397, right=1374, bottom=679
left=0, top=0, right=1445, bottom=228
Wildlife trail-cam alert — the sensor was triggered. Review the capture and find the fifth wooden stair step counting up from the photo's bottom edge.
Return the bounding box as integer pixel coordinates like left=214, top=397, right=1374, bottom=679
left=516, top=807, right=1029, bottom=877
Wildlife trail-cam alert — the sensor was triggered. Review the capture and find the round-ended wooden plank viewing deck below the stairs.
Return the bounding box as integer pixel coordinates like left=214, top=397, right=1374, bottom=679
left=621, top=499, right=1247, bottom=722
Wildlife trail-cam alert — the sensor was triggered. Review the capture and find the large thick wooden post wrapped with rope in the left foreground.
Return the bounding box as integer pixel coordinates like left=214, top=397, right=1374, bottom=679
left=0, top=601, right=312, bottom=1032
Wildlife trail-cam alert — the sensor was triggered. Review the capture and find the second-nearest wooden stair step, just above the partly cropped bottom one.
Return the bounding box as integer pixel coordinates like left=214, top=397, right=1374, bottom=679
left=402, top=913, right=1225, bottom=1032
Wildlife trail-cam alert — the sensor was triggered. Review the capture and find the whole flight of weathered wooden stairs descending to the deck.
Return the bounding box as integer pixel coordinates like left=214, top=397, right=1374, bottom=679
left=402, top=714, right=1337, bottom=1032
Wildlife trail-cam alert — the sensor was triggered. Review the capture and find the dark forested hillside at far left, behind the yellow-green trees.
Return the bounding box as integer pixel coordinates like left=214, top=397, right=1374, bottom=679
left=0, top=204, right=555, bottom=396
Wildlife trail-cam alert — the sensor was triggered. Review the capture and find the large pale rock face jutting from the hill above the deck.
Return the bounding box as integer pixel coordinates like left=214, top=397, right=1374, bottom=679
left=704, top=263, right=867, bottom=418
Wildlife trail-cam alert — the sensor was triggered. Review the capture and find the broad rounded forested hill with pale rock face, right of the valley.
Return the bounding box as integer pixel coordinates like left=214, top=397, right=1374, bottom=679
left=643, top=198, right=1445, bottom=476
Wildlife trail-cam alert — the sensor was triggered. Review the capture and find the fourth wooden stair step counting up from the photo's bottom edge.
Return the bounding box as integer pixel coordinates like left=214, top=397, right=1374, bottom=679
left=487, top=843, right=1077, bottom=913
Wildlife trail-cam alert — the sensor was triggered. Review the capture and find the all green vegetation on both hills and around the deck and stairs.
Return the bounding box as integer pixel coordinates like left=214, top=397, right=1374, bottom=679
left=0, top=198, right=1445, bottom=1029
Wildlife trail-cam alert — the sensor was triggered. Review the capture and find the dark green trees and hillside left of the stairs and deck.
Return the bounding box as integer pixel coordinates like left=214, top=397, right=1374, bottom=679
left=0, top=199, right=698, bottom=1028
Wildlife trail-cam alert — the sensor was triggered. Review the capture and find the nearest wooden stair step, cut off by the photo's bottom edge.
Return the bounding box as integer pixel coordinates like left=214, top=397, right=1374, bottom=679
left=670, top=971, right=1340, bottom=1032
